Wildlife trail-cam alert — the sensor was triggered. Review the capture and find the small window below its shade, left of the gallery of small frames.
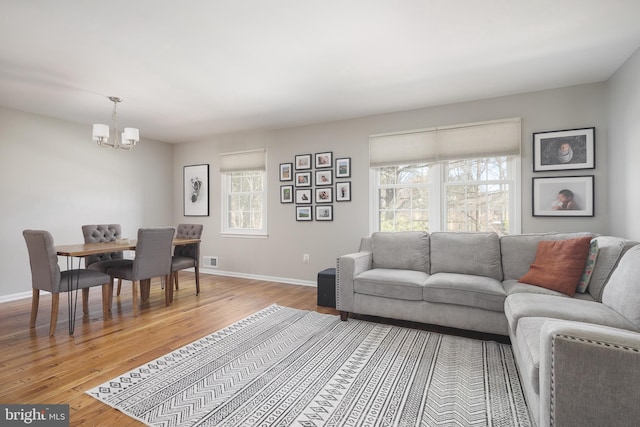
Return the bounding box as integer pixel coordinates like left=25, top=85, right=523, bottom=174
left=222, top=171, right=267, bottom=235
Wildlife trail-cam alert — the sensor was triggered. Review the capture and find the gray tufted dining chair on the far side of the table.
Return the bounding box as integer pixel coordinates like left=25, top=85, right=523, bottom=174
left=82, top=224, right=127, bottom=295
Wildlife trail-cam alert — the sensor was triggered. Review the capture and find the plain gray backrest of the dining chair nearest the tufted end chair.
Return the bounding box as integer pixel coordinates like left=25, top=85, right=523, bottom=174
left=132, top=227, right=176, bottom=280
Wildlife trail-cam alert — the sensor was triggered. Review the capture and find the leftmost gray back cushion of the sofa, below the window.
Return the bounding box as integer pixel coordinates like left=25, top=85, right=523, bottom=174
left=371, top=231, right=430, bottom=273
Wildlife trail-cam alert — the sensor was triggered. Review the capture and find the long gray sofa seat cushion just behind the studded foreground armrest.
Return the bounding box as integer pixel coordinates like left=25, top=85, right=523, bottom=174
left=504, top=293, right=638, bottom=333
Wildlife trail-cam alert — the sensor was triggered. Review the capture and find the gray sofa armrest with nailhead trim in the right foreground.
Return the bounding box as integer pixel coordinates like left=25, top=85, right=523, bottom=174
left=533, top=320, right=640, bottom=426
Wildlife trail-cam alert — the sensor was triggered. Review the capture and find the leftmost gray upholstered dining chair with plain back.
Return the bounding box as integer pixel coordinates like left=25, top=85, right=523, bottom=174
left=22, top=230, right=110, bottom=335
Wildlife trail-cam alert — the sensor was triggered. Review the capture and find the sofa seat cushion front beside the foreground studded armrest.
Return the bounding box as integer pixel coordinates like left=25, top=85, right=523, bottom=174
left=512, top=317, right=553, bottom=394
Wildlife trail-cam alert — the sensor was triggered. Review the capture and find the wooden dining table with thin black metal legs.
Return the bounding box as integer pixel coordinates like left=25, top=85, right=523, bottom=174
left=55, top=238, right=200, bottom=335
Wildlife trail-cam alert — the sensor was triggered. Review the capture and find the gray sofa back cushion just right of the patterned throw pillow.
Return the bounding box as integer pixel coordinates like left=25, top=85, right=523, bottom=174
left=587, top=236, right=637, bottom=301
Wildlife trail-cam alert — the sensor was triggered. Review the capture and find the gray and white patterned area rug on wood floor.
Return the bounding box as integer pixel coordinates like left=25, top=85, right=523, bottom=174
left=87, top=305, right=531, bottom=427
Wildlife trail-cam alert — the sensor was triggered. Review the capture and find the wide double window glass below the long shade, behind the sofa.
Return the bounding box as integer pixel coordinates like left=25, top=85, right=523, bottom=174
left=372, top=156, right=519, bottom=235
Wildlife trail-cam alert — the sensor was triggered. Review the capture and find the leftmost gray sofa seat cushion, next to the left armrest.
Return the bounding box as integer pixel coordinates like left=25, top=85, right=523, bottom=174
left=353, top=268, right=429, bottom=301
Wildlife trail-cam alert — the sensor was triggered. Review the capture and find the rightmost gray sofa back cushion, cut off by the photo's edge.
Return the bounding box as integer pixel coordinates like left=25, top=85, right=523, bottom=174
left=602, top=246, right=640, bottom=328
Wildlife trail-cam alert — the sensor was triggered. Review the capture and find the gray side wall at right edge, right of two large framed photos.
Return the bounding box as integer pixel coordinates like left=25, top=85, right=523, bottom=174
left=607, top=49, right=640, bottom=241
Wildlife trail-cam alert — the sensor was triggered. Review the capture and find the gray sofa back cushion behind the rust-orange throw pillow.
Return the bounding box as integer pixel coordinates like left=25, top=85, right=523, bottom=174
left=500, top=232, right=594, bottom=280
